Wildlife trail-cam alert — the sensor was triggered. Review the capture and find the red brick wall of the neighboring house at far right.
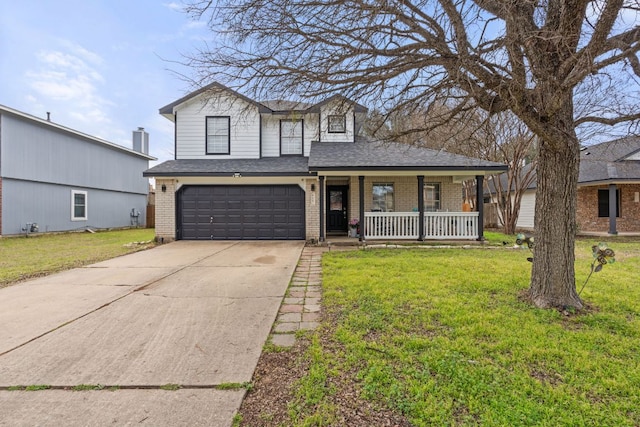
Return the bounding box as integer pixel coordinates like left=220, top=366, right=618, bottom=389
left=576, top=184, right=640, bottom=232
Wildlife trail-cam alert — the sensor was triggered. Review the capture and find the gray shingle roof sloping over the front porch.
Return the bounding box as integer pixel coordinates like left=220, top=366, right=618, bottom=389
left=309, top=141, right=507, bottom=172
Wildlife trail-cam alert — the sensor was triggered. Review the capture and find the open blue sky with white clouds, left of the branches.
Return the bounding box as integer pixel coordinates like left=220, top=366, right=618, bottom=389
left=0, top=0, right=211, bottom=166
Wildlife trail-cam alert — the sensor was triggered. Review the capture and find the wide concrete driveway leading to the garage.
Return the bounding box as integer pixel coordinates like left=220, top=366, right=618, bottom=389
left=0, top=242, right=304, bottom=426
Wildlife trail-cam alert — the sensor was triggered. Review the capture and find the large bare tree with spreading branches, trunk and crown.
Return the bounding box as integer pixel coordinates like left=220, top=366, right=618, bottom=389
left=181, top=0, right=640, bottom=308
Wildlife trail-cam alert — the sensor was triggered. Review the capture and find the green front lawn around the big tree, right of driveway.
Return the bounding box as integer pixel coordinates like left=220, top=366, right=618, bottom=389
left=290, top=234, right=640, bottom=426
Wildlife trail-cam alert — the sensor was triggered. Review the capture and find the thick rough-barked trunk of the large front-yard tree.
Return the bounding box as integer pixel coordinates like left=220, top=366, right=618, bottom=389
left=529, top=108, right=582, bottom=309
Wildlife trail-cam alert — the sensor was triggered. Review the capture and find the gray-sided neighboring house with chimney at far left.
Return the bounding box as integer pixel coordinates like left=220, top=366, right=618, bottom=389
left=0, top=105, right=155, bottom=235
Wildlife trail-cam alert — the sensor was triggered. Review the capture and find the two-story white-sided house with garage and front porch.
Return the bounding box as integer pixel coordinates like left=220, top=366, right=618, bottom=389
left=144, top=83, right=506, bottom=241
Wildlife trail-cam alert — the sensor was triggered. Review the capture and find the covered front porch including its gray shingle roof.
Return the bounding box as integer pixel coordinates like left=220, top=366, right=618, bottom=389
left=309, top=139, right=507, bottom=242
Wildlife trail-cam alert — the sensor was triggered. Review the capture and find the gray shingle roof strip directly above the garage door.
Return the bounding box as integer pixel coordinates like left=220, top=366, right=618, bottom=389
left=143, top=157, right=309, bottom=177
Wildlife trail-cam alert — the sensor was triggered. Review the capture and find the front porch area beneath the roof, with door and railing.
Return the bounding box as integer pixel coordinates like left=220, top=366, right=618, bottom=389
left=318, top=173, right=484, bottom=242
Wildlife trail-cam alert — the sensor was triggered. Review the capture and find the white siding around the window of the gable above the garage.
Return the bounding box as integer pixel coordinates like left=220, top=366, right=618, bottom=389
left=176, top=95, right=260, bottom=159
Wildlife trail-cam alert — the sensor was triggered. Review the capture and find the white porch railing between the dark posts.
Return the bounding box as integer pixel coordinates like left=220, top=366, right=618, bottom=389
left=364, top=212, right=478, bottom=240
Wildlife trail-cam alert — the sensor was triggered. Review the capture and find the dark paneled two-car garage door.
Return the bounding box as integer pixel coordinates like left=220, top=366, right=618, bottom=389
left=178, top=185, right=305, bottom=240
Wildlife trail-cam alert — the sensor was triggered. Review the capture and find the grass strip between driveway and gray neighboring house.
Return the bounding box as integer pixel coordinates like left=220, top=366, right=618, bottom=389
left=0, top=229, right=154, bottom=287
